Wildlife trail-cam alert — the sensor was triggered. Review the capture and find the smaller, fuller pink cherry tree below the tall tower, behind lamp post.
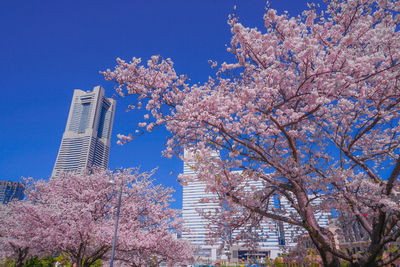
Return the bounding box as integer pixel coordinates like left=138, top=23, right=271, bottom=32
left=0, top=169, right=191, bottom=267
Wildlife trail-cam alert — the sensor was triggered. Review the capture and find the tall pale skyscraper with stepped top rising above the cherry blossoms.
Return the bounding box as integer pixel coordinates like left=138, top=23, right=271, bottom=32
left=51, top=86, right=116, bottom=177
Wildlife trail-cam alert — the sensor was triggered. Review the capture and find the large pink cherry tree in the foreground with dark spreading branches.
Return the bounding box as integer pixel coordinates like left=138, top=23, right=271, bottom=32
left=103, top=0, right=400, bottom=266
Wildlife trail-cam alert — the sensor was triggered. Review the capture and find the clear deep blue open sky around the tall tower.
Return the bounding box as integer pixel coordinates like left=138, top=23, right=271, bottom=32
left=0, top=0, right=312, bottom=208
